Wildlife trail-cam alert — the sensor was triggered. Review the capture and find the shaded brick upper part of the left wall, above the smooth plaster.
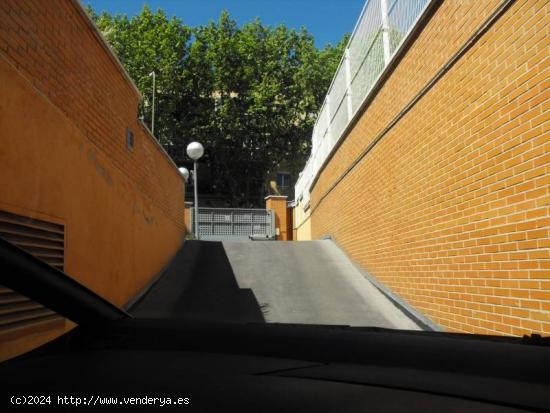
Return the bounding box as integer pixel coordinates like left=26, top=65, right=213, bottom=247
left=0, top=0, right=183, bottom=222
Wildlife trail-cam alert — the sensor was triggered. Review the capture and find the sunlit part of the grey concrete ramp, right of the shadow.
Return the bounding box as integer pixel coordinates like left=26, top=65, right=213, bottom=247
left=223, top=240, right=420, bottom=330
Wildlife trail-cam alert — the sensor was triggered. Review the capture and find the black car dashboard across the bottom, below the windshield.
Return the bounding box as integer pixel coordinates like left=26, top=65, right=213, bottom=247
left=0, top=319, right=550, bottom=412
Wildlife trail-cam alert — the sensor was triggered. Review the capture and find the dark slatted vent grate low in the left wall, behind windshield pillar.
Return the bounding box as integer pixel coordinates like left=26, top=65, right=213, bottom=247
left=0, top=211, right=65, bottom=342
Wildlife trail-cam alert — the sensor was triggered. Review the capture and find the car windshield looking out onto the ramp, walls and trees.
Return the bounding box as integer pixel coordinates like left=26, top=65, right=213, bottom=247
left=0, top=0, right=550, bottom=360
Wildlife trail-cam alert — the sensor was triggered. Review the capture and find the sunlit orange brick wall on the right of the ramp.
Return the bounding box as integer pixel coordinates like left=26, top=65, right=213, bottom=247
left=311, top=0, right=550, bottom=335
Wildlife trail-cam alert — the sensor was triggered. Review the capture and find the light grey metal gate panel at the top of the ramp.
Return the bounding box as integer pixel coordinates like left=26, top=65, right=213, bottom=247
left=191, top=207, right=275, bottom=241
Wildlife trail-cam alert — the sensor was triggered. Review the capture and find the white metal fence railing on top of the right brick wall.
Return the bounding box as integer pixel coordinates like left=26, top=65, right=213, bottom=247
left=295, top=0, right=434, bottom=204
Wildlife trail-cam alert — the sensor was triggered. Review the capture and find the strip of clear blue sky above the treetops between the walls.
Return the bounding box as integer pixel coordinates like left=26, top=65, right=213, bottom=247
left=81, top=0, right=365, bottom=47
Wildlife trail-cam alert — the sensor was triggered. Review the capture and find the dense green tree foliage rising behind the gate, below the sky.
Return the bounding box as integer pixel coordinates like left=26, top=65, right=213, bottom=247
left=88, top=6, right=347, bottom=206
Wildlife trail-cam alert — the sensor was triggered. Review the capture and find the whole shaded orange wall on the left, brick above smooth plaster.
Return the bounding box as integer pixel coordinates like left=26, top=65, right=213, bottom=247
left=0, top=0, right=185, bottom=360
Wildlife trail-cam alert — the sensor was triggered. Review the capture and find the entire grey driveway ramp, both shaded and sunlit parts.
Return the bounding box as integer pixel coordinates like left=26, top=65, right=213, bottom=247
left=133, top=240, right=419, bottom=330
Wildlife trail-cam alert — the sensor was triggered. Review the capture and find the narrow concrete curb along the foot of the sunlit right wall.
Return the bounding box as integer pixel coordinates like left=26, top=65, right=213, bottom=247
left=320, top=234, right=445, bottom=331
